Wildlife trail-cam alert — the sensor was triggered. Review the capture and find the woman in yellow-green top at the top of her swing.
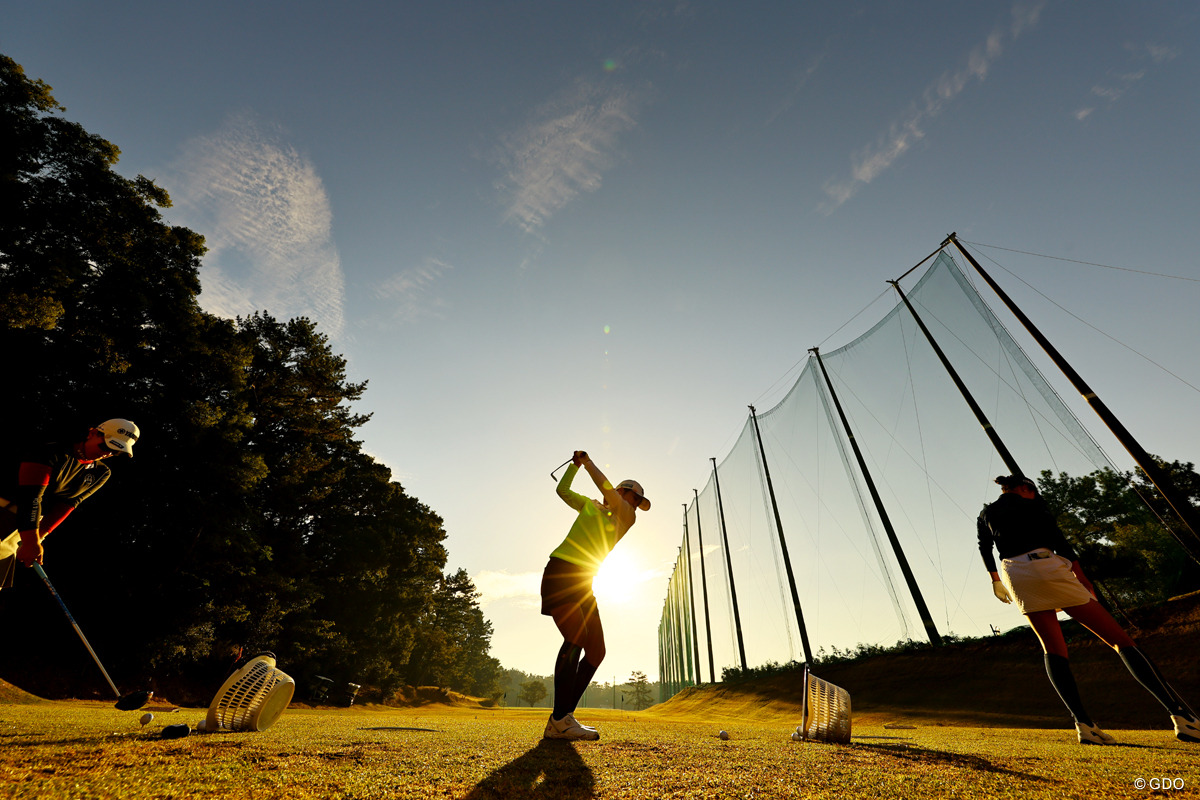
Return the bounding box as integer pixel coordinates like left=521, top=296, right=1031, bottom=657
left=541, top=450, right=650, bottom=741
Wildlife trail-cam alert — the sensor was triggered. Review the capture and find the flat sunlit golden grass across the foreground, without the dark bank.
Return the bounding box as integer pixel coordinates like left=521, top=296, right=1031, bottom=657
left=0, top=702, right=1200, bottom=800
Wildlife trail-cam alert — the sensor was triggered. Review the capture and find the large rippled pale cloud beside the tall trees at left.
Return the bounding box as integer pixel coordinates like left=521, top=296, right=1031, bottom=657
left=164, top=114, right=344, bottom=337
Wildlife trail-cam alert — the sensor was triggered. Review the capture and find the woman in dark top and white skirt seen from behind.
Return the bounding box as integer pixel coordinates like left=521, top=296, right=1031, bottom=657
left=978, top=475, right=1200, bottom=745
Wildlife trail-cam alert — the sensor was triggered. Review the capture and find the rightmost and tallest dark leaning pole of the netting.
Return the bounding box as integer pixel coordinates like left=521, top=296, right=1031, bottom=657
left=942, top=233, right=1200, bottom=563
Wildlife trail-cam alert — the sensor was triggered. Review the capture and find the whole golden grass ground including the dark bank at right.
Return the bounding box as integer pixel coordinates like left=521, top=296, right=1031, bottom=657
left=0, top=597, right=1200, bottom=800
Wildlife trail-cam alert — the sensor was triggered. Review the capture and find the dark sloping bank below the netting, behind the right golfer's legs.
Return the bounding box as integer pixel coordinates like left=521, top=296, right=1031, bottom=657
left=650, top=593, right=1200, bottom=728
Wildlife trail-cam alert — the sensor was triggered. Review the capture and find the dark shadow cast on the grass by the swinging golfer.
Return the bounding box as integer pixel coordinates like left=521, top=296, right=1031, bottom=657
left=463, top=739, right=595, bottom=800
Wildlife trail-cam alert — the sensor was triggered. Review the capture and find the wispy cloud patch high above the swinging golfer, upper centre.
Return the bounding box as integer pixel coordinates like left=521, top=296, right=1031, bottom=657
left=498, top=79, right=641, bottom=233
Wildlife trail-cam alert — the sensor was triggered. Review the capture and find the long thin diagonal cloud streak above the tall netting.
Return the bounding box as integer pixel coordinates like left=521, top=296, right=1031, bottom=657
left=820, top=2, right=1045, bottom=213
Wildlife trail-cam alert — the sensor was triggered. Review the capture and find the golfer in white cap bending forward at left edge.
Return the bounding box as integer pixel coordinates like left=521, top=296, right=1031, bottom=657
left=0, top=419, right=140, bottom=589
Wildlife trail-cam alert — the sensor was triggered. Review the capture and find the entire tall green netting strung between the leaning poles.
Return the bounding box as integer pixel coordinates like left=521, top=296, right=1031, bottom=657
left=662, top=253, right=1109, bottom=676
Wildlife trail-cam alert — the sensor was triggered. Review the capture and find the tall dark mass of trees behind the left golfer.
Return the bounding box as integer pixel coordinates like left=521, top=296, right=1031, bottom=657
left=0, top=55, right=500, bottom=702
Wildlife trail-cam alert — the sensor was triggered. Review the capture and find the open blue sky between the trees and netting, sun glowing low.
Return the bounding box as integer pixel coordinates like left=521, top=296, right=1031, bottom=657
left=0, top=0, right=1200, bottom=680
